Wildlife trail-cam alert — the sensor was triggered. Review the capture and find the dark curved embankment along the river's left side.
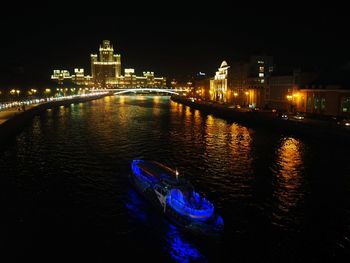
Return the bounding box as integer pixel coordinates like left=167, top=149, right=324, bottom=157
left=0, top=93, right=109, bottom=143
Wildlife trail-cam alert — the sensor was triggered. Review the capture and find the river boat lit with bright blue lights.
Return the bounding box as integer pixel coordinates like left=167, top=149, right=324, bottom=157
left=130, top=160, right=224, bottom=236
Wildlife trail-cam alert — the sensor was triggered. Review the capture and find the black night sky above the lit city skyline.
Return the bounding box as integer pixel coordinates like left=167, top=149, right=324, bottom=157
left=0, top=7, right=350, bottom=85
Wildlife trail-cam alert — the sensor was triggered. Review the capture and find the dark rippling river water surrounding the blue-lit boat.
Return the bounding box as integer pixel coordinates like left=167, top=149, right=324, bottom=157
left=0, top=96, right=350, bottom=262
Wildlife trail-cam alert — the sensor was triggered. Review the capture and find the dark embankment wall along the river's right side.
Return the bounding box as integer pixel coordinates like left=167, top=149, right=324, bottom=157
left=171, top=96, right=350, bottom=144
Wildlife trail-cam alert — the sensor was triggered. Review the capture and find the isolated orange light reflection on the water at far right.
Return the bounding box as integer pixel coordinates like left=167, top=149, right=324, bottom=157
left=272, top=137, right=303, bottom=226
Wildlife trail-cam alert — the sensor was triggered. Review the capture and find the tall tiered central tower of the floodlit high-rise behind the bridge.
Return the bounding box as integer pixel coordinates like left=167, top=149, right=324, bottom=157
left=91, top=40, right=121, bottom=87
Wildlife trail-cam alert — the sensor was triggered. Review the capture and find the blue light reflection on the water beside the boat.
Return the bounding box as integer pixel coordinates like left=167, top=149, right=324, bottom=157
left=126, top=188, right=207, bottom=262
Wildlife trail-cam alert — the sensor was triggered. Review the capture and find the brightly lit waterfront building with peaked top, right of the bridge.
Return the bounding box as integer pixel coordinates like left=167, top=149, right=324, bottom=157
left=209, top=60, right=230, bottom=102
